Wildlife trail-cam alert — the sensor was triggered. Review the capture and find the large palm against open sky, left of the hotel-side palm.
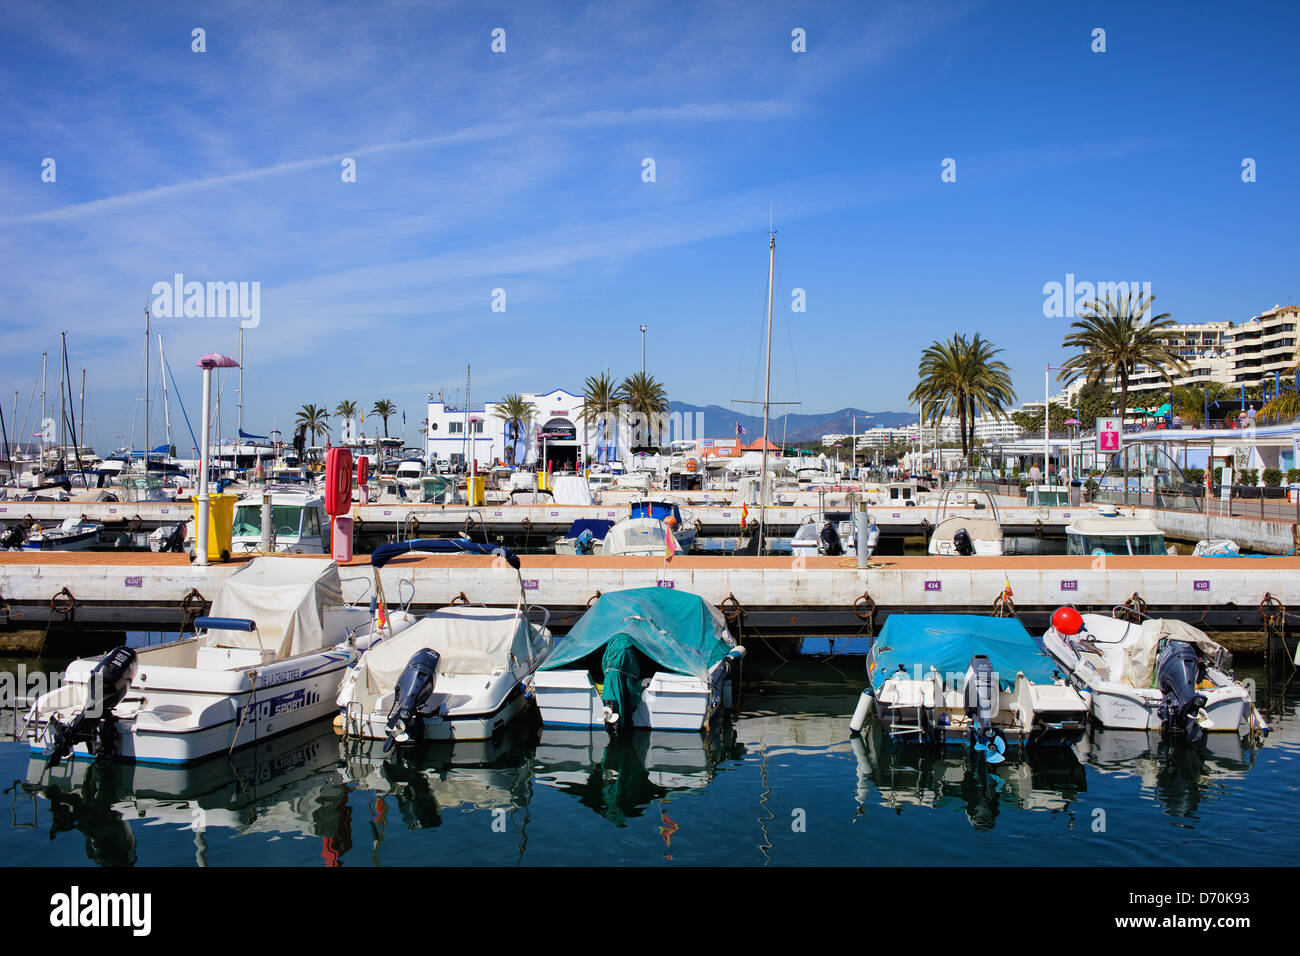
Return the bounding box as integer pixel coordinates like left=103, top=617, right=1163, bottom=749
left=909, top=333, right=1015, bottom=462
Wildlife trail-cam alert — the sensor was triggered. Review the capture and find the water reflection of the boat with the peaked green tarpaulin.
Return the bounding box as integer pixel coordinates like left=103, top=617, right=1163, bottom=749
left=536, top=719, right=745, bottom=827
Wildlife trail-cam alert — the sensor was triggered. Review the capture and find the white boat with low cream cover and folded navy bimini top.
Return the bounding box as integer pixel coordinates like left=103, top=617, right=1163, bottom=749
left=337, top=538, right=554, bottom=750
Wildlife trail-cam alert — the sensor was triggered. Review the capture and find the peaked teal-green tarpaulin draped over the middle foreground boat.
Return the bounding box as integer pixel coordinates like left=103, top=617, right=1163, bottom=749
left=541, top=588, right=736, bottom=680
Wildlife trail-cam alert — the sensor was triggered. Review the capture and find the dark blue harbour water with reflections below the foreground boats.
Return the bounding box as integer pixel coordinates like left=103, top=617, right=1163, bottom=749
left=0, top=648, right=1300, bottom=866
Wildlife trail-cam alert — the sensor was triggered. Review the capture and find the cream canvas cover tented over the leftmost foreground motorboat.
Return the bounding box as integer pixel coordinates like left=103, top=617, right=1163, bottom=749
left=204, top=558, right=343, bottom=661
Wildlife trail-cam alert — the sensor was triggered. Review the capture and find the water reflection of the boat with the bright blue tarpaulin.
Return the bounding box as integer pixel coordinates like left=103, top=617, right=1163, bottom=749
left=849, top=718, right=1087, bottom=830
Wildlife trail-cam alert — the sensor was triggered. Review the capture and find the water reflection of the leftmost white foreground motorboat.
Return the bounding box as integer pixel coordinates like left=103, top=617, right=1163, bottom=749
left=21, top=722, right=351, bottom=866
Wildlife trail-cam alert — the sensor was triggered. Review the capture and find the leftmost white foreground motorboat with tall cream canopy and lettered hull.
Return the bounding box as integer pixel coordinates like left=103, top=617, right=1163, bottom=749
left=27, top=557, right=415, bottom=763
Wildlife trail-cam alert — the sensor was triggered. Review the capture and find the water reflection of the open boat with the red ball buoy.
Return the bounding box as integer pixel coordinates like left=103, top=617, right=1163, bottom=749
left=1075, top=727, right=1257, bottom=817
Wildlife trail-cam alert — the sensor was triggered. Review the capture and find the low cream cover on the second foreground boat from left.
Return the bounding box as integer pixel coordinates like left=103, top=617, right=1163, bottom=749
left=356, top=607, right=554, bottom=705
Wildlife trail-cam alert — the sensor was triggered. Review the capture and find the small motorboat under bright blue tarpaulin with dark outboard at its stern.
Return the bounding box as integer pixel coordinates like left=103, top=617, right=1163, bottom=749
left=849, top=614, right=1088, bottom=762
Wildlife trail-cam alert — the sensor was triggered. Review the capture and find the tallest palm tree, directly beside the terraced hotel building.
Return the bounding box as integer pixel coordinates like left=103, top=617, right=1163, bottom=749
left=1057, top=293, right=1187, bottom=421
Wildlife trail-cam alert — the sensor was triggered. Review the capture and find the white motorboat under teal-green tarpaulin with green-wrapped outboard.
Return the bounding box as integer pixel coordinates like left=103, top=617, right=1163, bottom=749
left=533, top=588, right=745, bottom=731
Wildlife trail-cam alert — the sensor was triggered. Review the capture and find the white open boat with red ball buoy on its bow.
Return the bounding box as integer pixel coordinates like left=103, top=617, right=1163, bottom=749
left=1043, top=609, right=1265, bottom=735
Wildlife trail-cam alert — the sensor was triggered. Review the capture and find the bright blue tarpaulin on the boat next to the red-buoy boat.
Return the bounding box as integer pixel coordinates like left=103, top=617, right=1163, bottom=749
left=867, top=614, right=1060, bottom=691
